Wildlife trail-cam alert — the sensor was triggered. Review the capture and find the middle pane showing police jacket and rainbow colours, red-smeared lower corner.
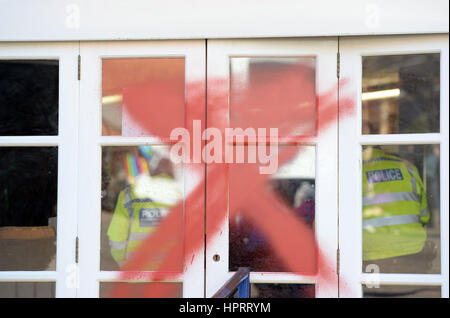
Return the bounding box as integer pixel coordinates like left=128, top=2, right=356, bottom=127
left=101, top=146, right=184, bottom=271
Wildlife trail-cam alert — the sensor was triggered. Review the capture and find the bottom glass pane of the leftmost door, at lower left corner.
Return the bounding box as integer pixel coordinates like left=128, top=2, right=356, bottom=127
left=0, top=282, right=55, bottom=298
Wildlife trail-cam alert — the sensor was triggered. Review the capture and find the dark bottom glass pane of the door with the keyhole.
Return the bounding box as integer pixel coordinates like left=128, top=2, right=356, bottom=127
left=250, top=284, right=316, bottom=298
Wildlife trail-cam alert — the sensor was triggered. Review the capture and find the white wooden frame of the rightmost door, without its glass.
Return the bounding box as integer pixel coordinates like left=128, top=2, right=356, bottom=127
left=339, top=34, right=449, bottom=297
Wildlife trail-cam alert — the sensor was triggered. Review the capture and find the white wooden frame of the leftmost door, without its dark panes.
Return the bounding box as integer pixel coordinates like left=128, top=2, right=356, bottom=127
left=0, top=42, right=79, bottom=297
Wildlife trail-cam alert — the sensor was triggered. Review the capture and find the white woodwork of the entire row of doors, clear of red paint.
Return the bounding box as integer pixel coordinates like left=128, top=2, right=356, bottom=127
left=0, top=34, right=449, bottom=297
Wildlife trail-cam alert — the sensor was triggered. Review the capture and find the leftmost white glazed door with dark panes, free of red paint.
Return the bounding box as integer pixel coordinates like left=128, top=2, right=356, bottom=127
left=0, top=42, right=78, bottom=298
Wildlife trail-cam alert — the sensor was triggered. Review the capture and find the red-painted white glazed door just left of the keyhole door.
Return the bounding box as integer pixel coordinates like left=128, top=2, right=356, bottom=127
left=78, top=41, right=205, bottom=297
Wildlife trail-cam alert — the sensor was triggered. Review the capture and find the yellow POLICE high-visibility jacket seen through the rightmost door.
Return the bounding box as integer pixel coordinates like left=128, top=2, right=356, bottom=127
left=363, top=147, right=430, bottom=260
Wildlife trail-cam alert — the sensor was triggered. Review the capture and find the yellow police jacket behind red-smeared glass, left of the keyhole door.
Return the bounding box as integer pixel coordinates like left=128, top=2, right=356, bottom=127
left=107, top=177, right=180, bottom=265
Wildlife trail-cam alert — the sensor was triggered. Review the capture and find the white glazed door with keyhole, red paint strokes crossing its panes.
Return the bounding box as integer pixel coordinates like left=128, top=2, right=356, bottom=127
left=206, top=38, right=338, bottom=297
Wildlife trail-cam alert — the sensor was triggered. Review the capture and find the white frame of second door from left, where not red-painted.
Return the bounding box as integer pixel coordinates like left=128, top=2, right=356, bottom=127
left=78, top=40, right=205, bottom=297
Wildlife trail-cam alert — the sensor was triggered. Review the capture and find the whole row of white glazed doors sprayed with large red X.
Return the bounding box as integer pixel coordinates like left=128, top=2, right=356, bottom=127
left=0, top=35, right=449, bottom=297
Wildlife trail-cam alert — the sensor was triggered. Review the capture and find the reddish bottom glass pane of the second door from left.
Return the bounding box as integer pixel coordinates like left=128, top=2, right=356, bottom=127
left=100, top=282, right=183, bottom=298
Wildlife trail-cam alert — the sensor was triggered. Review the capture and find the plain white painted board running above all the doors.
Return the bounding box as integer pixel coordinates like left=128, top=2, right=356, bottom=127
left=0, top=0, right=449, bottom=41
